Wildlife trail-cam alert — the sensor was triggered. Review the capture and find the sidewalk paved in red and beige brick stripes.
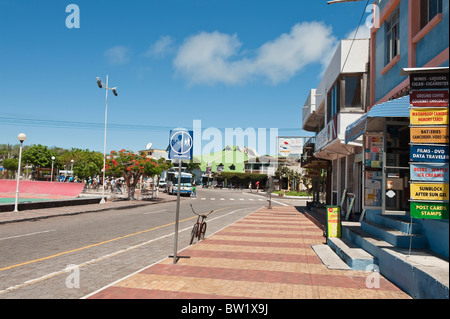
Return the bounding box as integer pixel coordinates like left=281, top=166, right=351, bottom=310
left=87, top=207, right=410, bottom=299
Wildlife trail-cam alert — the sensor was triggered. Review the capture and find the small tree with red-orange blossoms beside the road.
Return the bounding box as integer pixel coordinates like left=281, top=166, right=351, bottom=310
left=105, top=149, right=169, bottom=199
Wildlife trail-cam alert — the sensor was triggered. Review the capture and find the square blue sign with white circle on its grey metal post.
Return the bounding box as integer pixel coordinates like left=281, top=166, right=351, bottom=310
left=169, top=130, right=194, bottom=264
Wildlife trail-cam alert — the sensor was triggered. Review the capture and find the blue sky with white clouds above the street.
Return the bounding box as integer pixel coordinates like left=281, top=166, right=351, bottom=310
left=0, top=0, right=369, bottom=155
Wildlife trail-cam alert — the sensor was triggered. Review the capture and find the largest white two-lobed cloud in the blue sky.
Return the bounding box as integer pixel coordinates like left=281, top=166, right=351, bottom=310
left=173, top=22, right=336, bottom=85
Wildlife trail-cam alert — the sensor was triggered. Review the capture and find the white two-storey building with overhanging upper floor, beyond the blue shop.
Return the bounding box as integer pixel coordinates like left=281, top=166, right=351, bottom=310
left=302, top=39, right=369, bottom=213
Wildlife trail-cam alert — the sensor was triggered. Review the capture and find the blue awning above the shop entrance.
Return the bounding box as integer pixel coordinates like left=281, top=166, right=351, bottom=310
left=345, top=95, right=409, bottom=144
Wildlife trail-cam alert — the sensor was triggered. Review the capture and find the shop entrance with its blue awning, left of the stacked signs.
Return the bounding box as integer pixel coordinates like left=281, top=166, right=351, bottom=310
left=345, top=96, right=410, bottom=215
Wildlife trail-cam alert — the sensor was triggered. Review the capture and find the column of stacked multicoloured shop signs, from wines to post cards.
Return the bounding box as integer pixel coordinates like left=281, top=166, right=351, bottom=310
left=410, top=72, right=449, bottom=219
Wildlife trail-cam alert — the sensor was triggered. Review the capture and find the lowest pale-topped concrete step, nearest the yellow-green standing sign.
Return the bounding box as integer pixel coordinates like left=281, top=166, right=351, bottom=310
left=327, top=238, right=376, bottom=270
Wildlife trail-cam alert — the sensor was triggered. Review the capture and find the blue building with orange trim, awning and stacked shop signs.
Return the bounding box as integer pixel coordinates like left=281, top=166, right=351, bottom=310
left=345, top=0, right=449, bottom=258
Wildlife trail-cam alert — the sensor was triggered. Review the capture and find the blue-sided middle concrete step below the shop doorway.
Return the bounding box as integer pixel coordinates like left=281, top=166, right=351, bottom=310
left=361, top=221, right=427, bottom=249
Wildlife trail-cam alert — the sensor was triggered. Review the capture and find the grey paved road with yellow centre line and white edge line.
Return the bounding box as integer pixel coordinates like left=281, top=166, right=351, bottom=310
left=0, top=189, right=303, bottom=299
